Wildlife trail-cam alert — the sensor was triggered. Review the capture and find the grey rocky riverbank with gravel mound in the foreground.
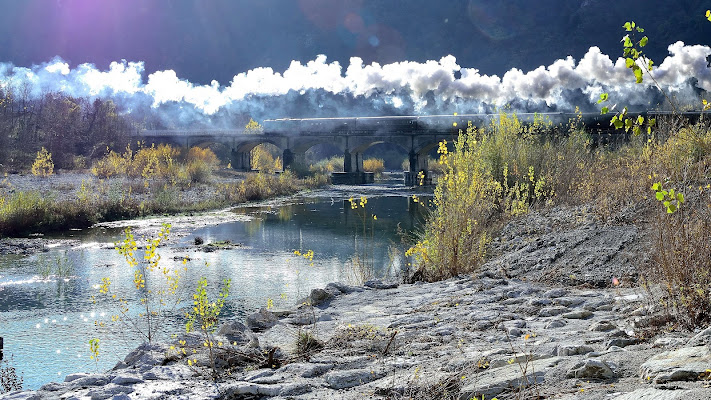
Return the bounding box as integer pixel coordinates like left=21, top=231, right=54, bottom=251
left=0, top=208, right=711, bottom=399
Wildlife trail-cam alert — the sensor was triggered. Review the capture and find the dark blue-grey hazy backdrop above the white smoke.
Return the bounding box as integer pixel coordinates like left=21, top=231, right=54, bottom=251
left=0, top=0, right=711, bottom=85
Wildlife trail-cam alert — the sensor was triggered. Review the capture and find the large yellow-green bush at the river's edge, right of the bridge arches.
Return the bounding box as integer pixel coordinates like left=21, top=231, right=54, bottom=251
left=407, top=113, right=553, bottom=280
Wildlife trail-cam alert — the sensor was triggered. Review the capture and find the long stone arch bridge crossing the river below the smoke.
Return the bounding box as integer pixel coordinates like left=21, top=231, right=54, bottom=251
left=134, top=113, right=636, bottom=185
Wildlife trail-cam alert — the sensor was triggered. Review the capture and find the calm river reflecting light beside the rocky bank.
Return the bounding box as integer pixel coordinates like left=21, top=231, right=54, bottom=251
left=0, top=185, right=427, bottom=389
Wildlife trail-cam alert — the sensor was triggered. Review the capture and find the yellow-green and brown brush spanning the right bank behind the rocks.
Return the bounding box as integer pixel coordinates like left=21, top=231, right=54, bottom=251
left=408, top=111, right=711, bottom=329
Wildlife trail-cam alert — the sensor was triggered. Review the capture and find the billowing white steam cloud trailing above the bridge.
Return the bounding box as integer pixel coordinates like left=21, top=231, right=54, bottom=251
left=0, top=42, right=711, bottom=127
